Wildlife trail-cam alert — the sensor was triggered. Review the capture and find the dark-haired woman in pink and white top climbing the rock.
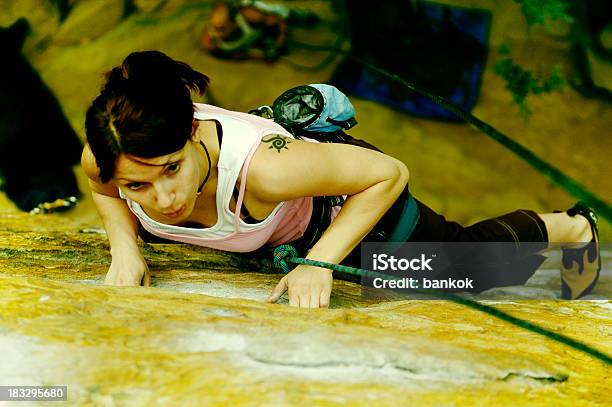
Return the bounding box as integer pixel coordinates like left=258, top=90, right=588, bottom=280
left=81, top=51, right=601, bottom=308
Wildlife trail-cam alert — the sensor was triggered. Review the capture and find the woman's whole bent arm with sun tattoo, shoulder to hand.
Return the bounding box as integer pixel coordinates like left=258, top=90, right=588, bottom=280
left=247, top=135, right=409, bottom=308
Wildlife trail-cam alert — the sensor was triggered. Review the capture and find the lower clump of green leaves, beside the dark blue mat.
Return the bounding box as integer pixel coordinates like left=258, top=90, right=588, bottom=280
left=493, top=43, right=564, bottom=119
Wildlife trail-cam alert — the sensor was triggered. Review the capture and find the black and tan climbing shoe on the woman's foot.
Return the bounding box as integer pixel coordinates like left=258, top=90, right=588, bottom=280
left=557, top=202, right=601, bottom=300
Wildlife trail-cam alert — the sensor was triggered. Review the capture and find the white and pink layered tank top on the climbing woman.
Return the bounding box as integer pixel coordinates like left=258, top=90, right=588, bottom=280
left=120, top=103, right=316, bottom=252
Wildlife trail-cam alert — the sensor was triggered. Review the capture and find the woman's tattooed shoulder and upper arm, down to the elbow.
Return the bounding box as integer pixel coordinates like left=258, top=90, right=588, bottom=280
left=247, top=134, right=407, bottom=202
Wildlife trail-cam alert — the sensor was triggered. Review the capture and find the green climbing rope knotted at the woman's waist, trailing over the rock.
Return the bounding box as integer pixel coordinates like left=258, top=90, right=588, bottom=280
left=274, top=245, right=612, bottom=365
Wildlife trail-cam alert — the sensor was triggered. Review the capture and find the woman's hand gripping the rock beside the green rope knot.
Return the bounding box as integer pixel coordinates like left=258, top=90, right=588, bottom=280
left=266, top=265, right=333, bottom=308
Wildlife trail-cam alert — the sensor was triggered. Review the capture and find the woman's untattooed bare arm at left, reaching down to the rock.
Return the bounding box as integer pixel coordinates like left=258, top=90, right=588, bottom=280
left=81, top=144, right=151, bottom=286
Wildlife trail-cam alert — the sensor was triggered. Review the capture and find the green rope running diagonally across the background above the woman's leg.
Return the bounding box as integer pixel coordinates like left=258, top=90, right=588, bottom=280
left=291, top=40, right=612, bottom=222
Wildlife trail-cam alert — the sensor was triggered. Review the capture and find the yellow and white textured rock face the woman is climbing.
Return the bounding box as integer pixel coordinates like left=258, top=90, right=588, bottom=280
left=0, top=212, right=612, bottom=406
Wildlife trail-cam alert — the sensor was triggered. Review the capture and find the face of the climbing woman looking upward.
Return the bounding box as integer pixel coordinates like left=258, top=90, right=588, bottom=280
left=113, top=138, right=207, bottom=224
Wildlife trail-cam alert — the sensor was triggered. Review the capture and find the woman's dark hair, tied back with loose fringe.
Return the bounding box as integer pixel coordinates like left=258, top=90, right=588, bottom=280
left=85, top=51, right=209, bottom=182
